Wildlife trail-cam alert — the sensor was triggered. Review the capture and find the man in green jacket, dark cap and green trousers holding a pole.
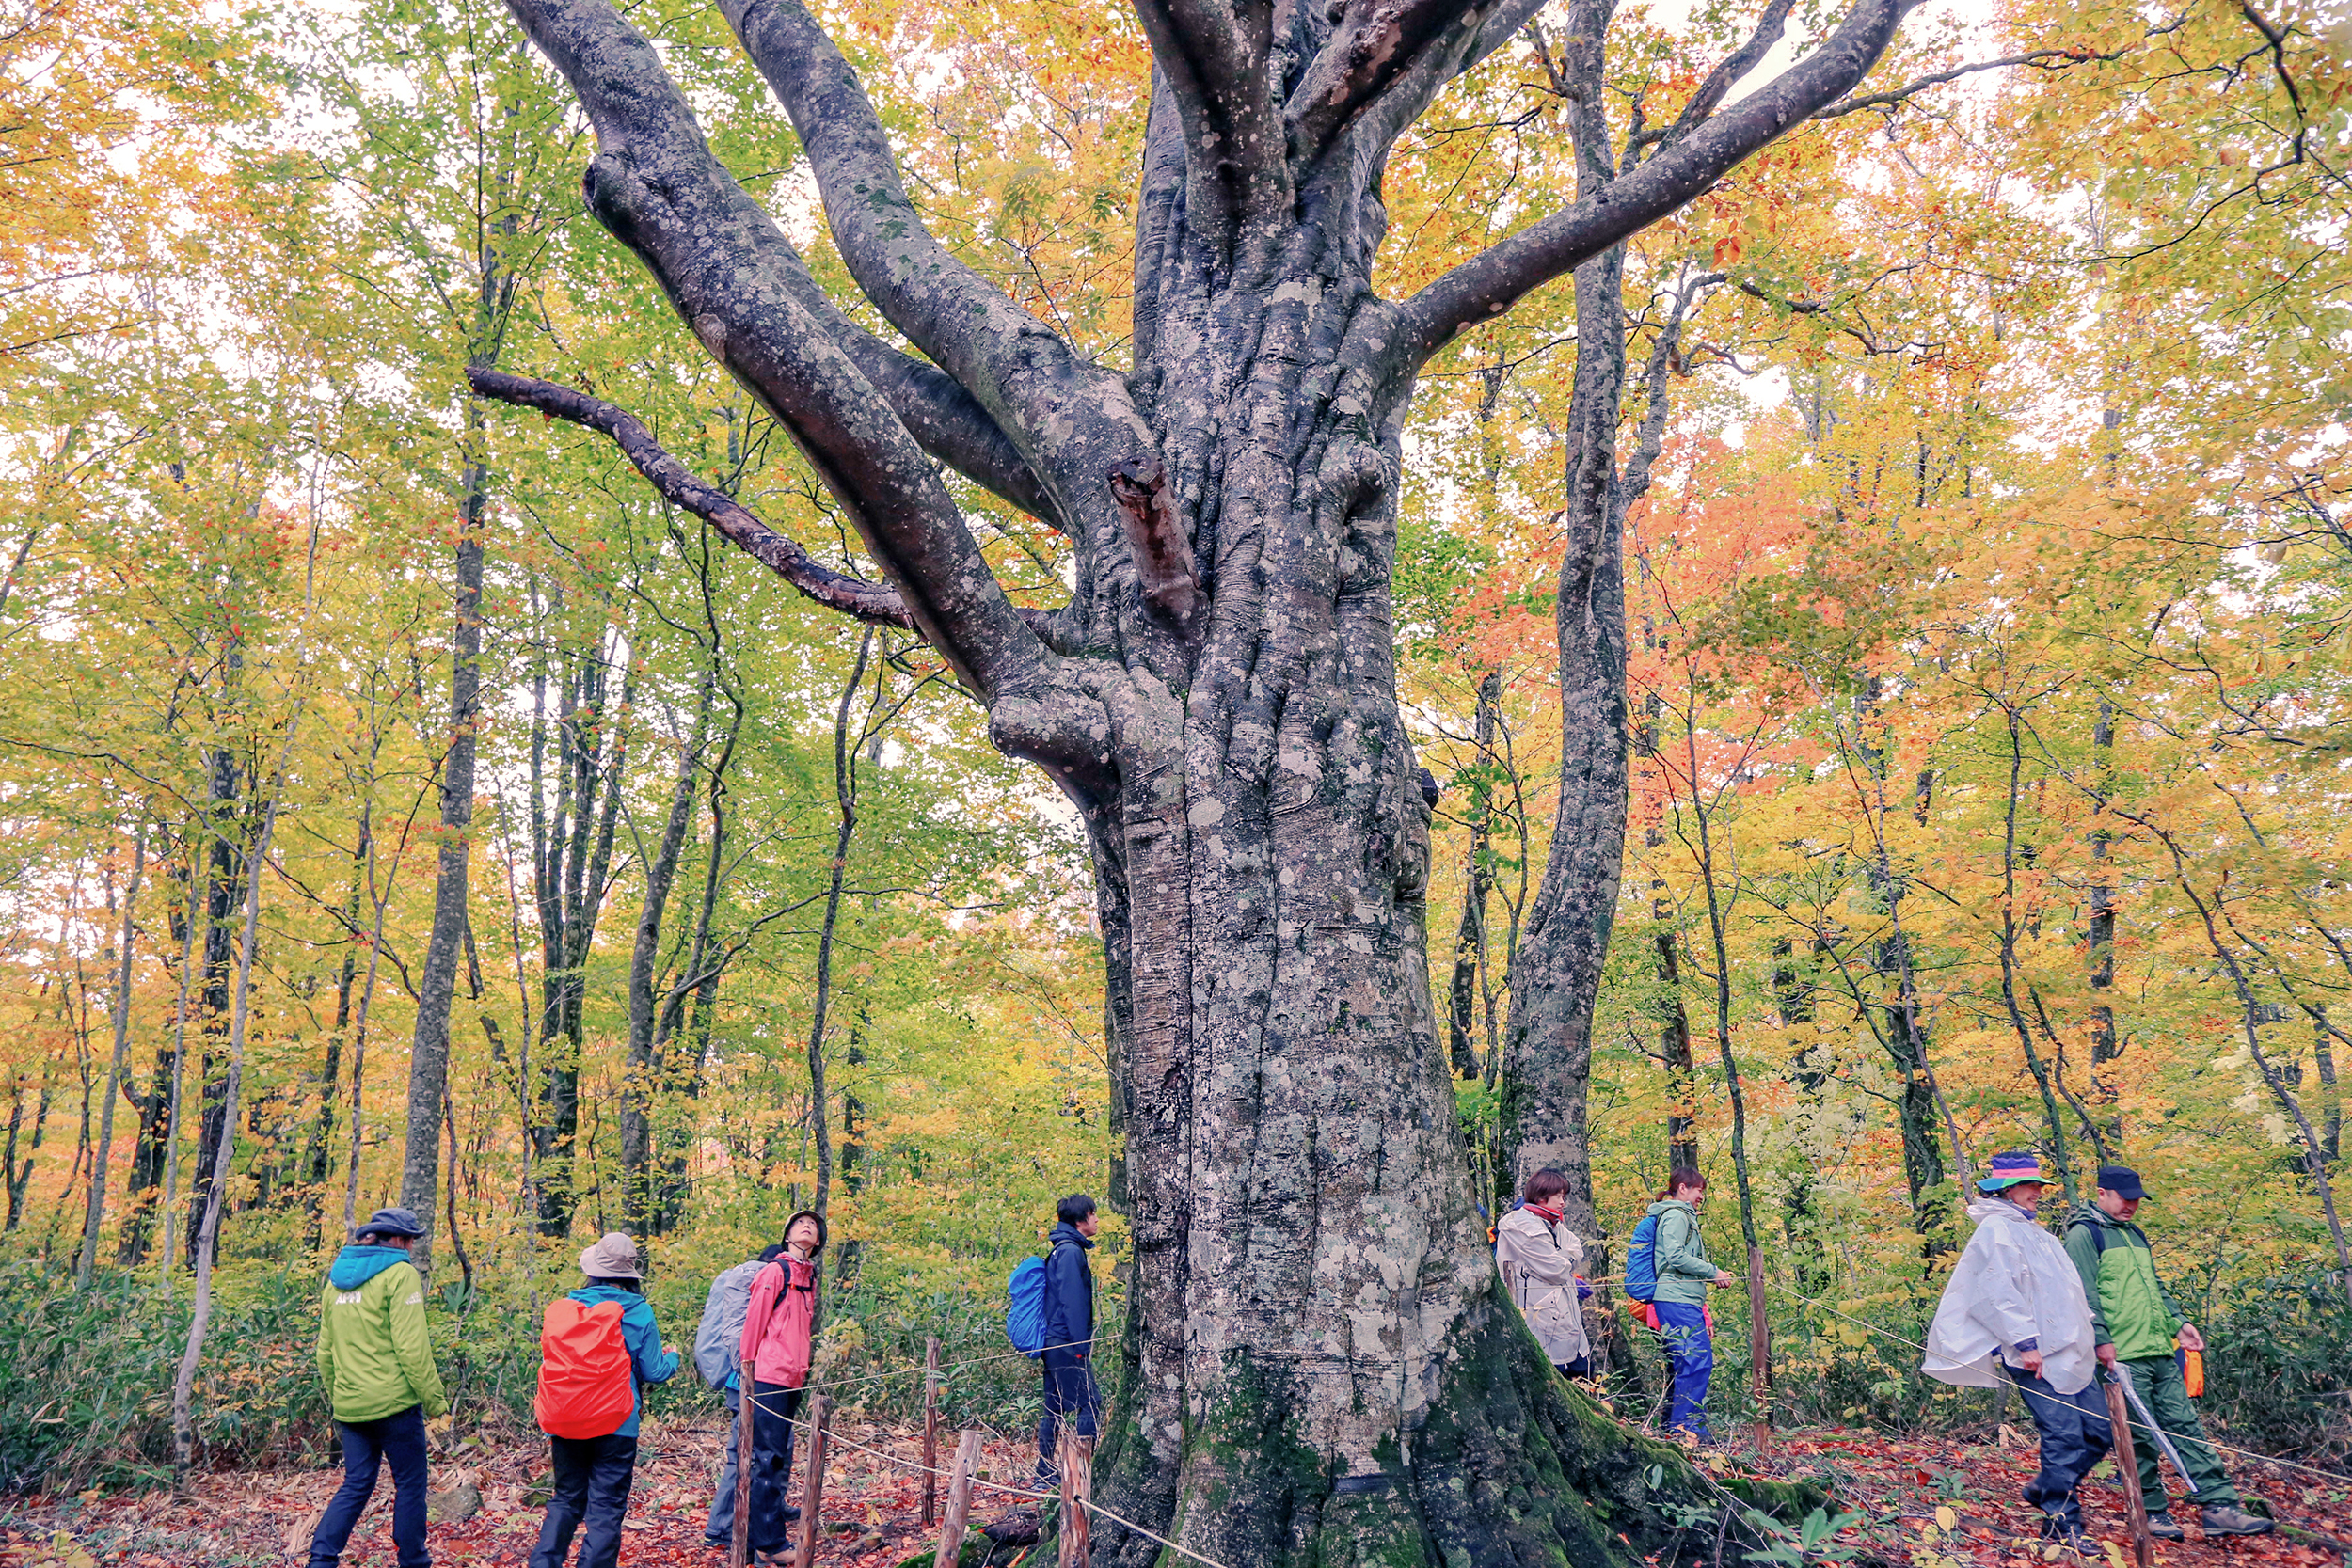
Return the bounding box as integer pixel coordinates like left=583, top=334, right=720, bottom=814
left=2065, top=1166, right=2275, bottom=1540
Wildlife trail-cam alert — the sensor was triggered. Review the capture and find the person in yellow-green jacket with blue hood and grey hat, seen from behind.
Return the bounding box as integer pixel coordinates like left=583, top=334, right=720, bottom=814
left=310, top=1209, right=450, bottom=1568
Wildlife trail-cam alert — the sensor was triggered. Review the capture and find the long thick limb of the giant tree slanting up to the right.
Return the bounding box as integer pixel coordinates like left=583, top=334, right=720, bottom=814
left=1392, top=0, right=1919, bottom=369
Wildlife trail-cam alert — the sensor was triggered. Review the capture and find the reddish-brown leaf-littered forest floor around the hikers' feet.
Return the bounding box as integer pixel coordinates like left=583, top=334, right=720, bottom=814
left=0, top=1420, right=2352, bottom=1568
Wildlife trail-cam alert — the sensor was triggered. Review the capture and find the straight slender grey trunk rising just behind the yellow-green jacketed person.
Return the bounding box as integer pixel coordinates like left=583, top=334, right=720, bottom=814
left=400, top=451, right=489, bottom=1279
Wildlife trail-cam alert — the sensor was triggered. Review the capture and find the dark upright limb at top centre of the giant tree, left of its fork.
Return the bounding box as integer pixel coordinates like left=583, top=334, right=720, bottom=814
left=1136, top=0, right=1292, bottom=251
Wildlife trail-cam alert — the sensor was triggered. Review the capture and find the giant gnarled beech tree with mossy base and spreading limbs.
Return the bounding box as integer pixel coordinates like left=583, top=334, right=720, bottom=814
left=470, top=0, right=1910, bottom=1568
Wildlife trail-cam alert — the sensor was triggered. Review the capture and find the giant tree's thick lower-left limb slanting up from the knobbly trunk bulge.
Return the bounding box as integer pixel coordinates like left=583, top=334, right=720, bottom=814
left=508, top=0, right=1047, bottom=698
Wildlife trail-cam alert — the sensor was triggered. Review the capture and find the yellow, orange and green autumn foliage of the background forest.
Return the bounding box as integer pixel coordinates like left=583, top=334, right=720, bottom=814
left=0, top=0, right=2352, bottom=1542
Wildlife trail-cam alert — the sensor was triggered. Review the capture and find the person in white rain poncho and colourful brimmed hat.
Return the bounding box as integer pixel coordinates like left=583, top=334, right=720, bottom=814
left=1919, top=1149, right=2112, bottom=1552
